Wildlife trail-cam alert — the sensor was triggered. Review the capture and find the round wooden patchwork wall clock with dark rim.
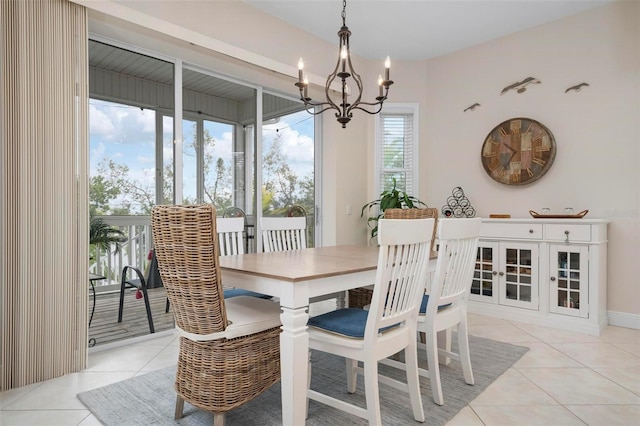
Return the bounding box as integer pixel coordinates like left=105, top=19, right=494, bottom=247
left=482, top=118, right=556, bottom=185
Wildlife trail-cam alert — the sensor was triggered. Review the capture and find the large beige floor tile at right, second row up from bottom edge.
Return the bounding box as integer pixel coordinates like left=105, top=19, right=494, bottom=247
left=518, top=368, right=640, bottom=405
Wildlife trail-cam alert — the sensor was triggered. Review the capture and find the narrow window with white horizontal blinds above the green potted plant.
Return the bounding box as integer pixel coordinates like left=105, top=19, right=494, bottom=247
left=377, top=113, right=414, bottom=193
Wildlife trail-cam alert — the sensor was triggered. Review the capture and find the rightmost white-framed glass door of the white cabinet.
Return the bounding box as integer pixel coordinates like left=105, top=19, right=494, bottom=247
left=549, top=245, right=589, bottom=318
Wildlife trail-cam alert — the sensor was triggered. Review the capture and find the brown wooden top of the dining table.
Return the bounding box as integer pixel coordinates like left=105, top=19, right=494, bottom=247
left=220, top=246, right=378, bottom=282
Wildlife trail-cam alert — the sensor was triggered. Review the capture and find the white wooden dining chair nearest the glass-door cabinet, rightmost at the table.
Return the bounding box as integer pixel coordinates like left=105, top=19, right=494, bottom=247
left=383, top=218, right=482, bottom=405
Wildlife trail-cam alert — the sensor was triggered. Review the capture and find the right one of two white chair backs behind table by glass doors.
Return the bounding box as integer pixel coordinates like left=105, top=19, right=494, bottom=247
left=260, top=217, right=307, bottom=253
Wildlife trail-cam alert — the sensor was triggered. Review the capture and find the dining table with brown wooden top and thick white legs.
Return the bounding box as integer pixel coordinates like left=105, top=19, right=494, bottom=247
left=220, top=245, right=379, bottom=426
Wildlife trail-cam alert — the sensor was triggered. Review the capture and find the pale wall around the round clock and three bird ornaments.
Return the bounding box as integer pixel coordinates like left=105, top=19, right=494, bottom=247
left=418, top=2, right=640, bottom=314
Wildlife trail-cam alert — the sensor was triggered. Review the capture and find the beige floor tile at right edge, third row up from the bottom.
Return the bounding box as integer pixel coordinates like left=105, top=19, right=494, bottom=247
left=550, top=342, right=640, bottom=368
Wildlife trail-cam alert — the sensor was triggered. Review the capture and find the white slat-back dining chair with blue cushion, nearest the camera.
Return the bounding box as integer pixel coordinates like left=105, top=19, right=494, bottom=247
left=307, top=219, right=434, bottom=425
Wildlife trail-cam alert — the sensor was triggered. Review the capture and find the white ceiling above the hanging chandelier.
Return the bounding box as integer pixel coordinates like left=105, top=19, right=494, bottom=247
left=243, top=0, right=615, bottom=60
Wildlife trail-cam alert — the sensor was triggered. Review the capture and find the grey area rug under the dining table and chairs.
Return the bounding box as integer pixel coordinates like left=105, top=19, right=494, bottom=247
left=78, top=336, right=528, bottom=426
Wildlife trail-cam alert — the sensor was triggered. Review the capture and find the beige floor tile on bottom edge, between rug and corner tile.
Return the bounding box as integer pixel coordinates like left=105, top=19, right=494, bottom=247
left=474, top=405, right=584, bottom=426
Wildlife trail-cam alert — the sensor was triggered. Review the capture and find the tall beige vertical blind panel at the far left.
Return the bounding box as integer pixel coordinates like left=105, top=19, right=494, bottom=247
left=0, top=0, right=88, bottom=390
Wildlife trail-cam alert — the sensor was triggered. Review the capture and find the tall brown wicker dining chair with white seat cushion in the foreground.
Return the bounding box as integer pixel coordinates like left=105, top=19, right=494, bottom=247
left=151, top=205, right=281, bottom=425
